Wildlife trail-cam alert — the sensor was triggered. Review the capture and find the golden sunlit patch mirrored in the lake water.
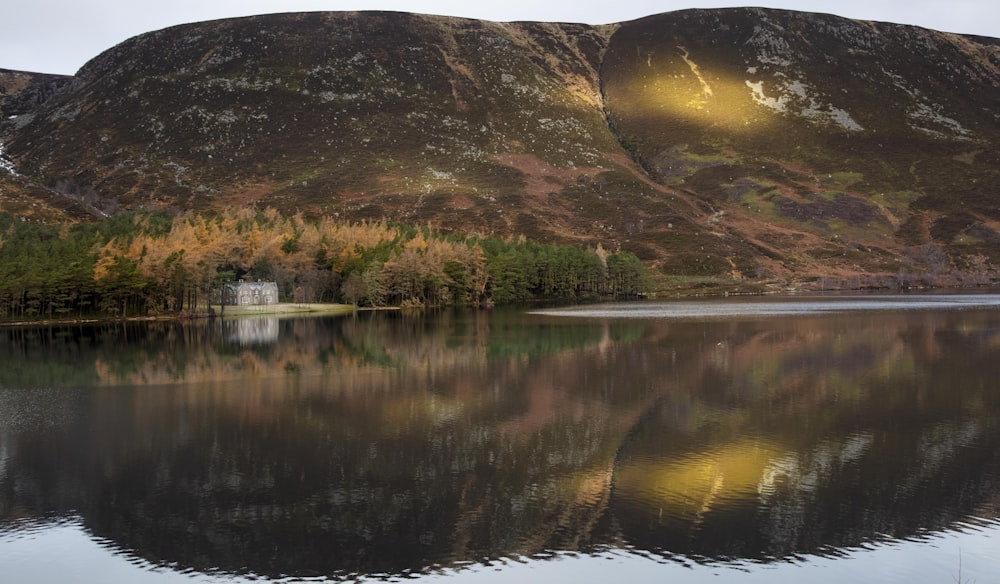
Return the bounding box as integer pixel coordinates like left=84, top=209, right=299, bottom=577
left=614, top=441, right=787, bottom=520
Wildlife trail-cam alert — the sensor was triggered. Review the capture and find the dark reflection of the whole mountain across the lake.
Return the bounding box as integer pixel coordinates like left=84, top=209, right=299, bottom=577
left=0, top=313, right=1000, bottom=577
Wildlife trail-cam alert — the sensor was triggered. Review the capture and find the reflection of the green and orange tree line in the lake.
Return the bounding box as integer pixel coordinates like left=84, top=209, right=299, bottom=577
left=0, top=310, right=634, bottom=387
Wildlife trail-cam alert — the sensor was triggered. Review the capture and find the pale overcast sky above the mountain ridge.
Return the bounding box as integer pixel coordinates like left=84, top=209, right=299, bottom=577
left=0, top=0, right=1000, bottom=74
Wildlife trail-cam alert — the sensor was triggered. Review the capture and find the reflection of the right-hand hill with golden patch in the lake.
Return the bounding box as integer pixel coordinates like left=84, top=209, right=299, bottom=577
left=610, top=315, right=1000, bottom=560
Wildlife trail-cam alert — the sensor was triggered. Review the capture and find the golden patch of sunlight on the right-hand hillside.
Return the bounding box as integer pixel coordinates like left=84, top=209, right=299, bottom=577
left=634, top=47, right=777, bottom=132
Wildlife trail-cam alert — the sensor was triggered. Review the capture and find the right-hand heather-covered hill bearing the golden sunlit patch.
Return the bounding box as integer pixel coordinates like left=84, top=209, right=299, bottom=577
left=602, top=9, right=1000, bottom=282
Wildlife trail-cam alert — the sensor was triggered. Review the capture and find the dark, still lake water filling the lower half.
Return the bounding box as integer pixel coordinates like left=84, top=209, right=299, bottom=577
left=0, top=296, right=1000, bottom=583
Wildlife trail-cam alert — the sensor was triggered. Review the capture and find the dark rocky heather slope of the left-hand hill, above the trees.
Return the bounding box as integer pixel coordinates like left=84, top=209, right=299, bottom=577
left=1, top=13, right=617, bottom=218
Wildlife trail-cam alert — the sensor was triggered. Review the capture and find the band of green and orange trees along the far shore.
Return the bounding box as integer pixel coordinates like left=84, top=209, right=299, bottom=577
left=0, top=208, right=649, bottom=320
